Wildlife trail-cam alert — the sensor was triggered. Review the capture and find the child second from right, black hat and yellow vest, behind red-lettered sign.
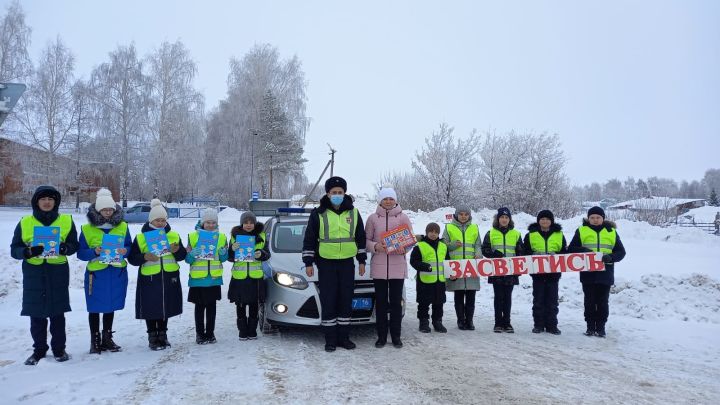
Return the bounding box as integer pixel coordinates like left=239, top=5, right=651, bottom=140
left=523, top=210, right=567, bottom=335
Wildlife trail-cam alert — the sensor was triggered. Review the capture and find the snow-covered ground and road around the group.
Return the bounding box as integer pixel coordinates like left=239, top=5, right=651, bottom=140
left=0, top=201, right=720, bottom=404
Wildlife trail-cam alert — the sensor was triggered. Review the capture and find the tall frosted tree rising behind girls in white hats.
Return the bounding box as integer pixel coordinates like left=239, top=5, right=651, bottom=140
left=90, top=44, right=149, bottom=206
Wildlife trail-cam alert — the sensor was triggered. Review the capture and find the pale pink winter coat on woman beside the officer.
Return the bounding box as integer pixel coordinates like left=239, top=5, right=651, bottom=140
left=365, top=205, right=414, bottom=279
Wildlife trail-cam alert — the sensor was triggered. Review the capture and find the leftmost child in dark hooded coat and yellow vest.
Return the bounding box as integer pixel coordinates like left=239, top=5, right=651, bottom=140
left=10, top=186, right=78, bottom=365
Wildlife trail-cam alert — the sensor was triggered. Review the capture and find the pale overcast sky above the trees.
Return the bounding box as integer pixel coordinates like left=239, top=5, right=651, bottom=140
left=16, top=0, right=720, bottom=193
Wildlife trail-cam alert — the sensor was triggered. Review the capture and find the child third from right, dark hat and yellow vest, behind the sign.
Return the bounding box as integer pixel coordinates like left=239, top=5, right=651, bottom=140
left=482, top=207, right=523, bottom=333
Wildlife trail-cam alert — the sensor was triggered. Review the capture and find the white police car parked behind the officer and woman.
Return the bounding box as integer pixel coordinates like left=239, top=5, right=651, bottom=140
left=260, top=208, right=404, bottom=333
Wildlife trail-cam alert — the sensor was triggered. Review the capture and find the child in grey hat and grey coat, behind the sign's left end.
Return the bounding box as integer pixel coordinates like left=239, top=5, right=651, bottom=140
left=442, top=206, right=482, bottom=330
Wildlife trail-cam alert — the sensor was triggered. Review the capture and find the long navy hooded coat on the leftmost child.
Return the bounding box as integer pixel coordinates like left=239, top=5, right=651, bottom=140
left=10, top=186, right=79, bottom=318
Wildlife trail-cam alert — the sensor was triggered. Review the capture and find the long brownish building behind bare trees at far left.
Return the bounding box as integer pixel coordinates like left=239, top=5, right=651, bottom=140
left=0, top=137, right=120, bottom=205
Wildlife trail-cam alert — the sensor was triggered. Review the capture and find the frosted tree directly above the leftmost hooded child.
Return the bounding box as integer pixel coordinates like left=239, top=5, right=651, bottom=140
left=17, top=36, right=76, bottom=183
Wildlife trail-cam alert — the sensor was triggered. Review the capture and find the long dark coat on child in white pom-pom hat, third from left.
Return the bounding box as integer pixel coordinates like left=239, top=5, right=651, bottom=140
left=128, top=222, right=187, bottom=319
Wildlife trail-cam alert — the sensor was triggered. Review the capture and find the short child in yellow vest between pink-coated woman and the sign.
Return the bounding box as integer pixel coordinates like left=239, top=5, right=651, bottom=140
left=410, top=222, right=450, bottom=333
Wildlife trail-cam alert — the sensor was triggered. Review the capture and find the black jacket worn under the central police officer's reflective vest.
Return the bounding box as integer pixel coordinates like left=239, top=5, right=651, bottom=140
left=302, top=194, right=367, bottom=266
